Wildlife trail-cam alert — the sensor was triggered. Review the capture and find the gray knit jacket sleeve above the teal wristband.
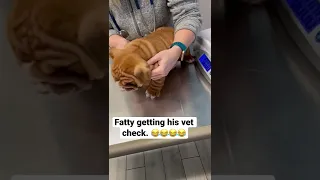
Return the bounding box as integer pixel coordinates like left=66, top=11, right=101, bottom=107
left=167, top=0, right=202, bottom=34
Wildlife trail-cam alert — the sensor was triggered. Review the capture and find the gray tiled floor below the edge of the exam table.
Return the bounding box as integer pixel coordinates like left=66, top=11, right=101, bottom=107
left=109, top=139, right=211, bottom=180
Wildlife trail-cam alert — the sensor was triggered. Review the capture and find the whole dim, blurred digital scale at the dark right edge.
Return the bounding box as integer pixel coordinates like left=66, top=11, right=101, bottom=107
left=279, top=0, right=320, bottom=71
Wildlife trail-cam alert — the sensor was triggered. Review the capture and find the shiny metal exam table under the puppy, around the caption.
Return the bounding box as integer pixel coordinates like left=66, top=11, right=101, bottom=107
left=109, top=63, right=211, bottom=158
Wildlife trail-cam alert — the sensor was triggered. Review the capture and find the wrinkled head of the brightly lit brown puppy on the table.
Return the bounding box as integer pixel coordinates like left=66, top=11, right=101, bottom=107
left=110, top=49, right=151, bottom=91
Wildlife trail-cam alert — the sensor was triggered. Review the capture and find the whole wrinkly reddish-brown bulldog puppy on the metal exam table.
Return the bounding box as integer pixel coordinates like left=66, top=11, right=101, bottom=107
left=110, top=27, right=192, bottom=99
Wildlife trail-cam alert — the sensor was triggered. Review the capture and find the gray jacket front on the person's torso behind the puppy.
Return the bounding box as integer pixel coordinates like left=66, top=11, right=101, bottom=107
left=109, top=0, right=172, bottom=40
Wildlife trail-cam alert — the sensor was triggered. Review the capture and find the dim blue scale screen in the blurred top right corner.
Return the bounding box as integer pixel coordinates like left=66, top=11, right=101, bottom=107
left=286, top=0, right=320, bottom=33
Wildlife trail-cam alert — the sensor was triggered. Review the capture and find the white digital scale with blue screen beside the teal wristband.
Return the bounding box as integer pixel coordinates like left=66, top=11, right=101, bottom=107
left=190, top=28, right=211, bottom=84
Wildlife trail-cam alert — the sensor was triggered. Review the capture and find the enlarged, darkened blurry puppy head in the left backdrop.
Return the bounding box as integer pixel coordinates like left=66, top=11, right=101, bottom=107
left=7, top=0, right=109, bottom=94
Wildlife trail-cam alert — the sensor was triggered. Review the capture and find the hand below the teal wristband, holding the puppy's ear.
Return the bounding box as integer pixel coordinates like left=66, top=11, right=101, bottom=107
left=148, top=46, right=181, bottom=80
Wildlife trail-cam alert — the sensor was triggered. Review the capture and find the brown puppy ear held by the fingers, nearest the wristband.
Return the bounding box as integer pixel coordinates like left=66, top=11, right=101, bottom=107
left=134, top=64, right=151, bottom=86
